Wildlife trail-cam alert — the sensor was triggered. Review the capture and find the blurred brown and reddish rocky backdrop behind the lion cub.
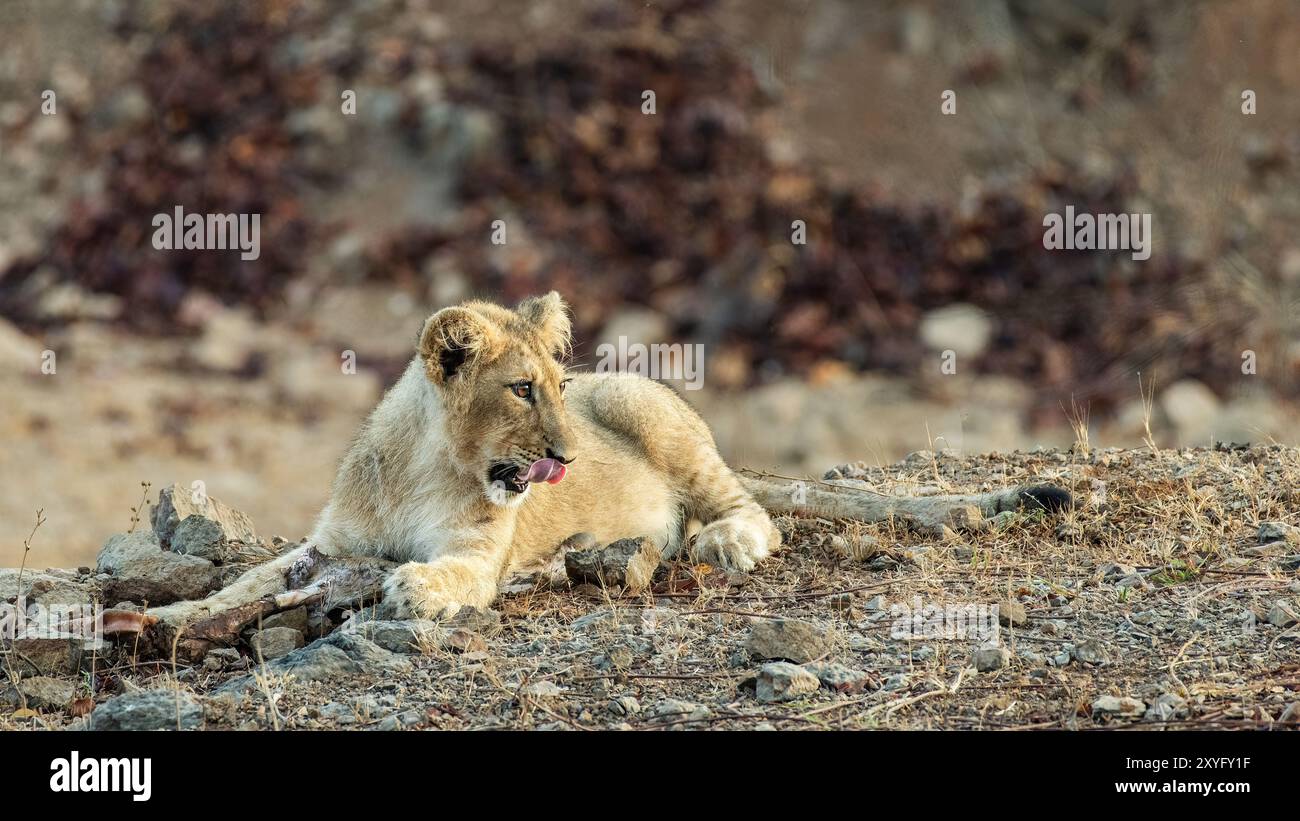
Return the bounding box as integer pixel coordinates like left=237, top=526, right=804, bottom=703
left=0, top=0, right=1300, bottom=566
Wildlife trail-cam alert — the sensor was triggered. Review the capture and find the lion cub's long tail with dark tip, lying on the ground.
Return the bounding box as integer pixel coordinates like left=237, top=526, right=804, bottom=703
left=740, top=475, right=1074, bottom=529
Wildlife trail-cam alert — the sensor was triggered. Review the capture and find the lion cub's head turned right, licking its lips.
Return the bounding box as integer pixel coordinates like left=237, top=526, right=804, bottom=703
left=419, top=291, right=576, bottom=505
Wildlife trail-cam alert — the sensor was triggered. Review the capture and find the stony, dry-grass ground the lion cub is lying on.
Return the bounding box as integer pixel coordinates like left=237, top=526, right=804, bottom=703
left=0, top=443, right=1300, bottom=730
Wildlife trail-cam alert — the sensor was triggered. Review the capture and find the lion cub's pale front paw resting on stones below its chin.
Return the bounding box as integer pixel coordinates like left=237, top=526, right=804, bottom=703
left=384, top=542, right=506, bottom=618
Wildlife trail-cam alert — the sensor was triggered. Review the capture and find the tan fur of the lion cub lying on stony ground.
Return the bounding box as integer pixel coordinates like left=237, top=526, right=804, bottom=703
left=153, top=292, right=1066, bottom=624
